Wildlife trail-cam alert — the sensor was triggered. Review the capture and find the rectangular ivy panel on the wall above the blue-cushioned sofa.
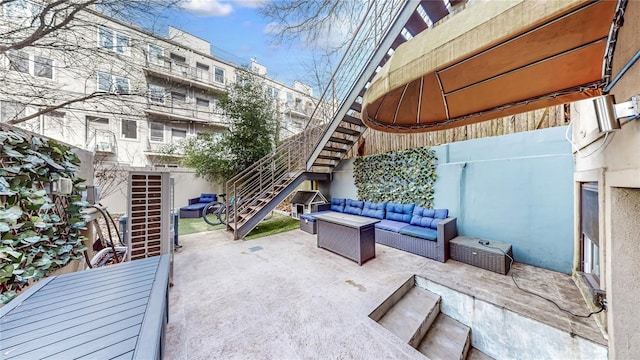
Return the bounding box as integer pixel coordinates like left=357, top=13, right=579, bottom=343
left=353, top=147, right=438, bottom=208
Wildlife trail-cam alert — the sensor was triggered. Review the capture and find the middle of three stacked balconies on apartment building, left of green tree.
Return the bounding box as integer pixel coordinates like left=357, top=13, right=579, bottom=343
left=145, top=101, right=228, bottom=128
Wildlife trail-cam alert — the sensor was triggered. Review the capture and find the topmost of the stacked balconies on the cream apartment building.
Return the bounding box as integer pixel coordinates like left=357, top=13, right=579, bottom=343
left=145, top=61, right=227, bottom=93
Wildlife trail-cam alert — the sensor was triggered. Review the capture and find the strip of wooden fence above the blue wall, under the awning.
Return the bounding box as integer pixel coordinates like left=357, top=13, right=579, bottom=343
left=347, top=105, right=569, bottom=158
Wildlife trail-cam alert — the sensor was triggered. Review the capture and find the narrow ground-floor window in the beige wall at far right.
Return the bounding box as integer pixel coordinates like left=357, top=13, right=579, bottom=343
left=580, top=183, right=600, bottom=284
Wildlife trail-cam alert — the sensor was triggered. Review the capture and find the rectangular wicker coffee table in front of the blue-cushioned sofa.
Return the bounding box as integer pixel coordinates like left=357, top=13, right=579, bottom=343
left=314, top=213, right=380, bottom=265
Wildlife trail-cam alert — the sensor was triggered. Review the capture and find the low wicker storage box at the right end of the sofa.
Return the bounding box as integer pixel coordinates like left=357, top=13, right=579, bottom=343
left=449, top=236, right=513, bottom=275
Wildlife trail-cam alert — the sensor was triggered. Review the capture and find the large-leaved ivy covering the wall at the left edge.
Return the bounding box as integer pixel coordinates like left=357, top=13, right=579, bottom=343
left=0, top=130, right=86, bottom=303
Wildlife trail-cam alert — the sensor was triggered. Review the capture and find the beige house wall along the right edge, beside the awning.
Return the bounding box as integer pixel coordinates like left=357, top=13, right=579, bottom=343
left=572, top=1, right=640, bottom=359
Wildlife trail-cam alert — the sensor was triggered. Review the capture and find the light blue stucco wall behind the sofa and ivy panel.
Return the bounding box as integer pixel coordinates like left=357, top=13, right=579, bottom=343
left=328, top=127, right=574, bottom=274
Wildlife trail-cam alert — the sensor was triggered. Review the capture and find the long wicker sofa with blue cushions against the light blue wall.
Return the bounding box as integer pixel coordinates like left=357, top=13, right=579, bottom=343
left=300, top=198, right=458, bottom=262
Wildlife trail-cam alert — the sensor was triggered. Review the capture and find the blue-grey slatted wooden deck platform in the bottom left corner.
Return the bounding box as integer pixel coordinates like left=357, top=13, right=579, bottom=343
left=0, top=255, right=169, bottom=359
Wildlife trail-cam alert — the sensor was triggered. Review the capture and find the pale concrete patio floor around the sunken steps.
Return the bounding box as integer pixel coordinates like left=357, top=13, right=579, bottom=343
left=165, top=230, right=606, bottom=359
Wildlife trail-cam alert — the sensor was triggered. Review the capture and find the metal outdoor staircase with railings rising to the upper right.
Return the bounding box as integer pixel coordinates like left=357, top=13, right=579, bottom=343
left=226, top=0, right=456, bottom=239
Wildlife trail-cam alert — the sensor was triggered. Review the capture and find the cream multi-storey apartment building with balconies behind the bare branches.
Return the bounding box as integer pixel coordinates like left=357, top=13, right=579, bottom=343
left=0, top=0, right=318, bottom=166
